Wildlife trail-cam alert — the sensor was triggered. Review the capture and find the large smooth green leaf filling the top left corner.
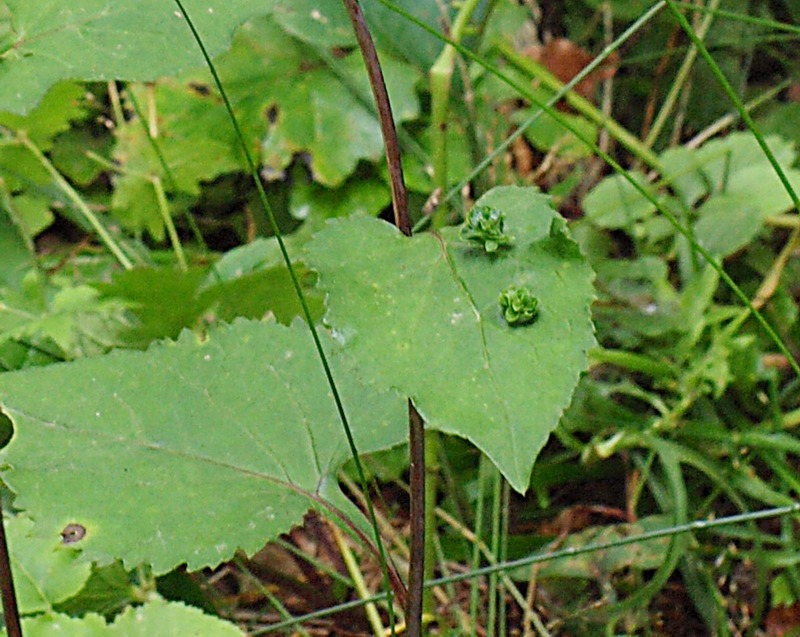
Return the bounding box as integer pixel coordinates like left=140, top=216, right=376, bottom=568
left=0, top=0, right=270, bottom=114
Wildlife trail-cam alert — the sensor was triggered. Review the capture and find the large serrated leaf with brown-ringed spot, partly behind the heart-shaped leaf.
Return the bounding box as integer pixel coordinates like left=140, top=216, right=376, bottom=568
left=0, top=320, right=405, bottom=573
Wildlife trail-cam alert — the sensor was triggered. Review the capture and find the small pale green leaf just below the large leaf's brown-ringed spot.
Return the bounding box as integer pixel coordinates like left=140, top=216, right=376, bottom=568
left=5, top=516, right=91, bottom=615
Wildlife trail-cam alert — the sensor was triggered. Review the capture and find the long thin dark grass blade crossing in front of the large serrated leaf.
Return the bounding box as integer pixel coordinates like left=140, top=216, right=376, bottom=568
left=174, top=0, right=406, bottom=624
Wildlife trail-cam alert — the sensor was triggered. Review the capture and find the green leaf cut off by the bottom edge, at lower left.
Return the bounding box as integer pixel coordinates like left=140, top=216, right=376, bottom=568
left=0, top=599, right=243, bottom=637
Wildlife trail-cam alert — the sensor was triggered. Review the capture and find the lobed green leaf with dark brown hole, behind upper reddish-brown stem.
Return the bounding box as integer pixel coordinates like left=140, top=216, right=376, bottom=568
left=217, top=19, right=418, bottom=186
